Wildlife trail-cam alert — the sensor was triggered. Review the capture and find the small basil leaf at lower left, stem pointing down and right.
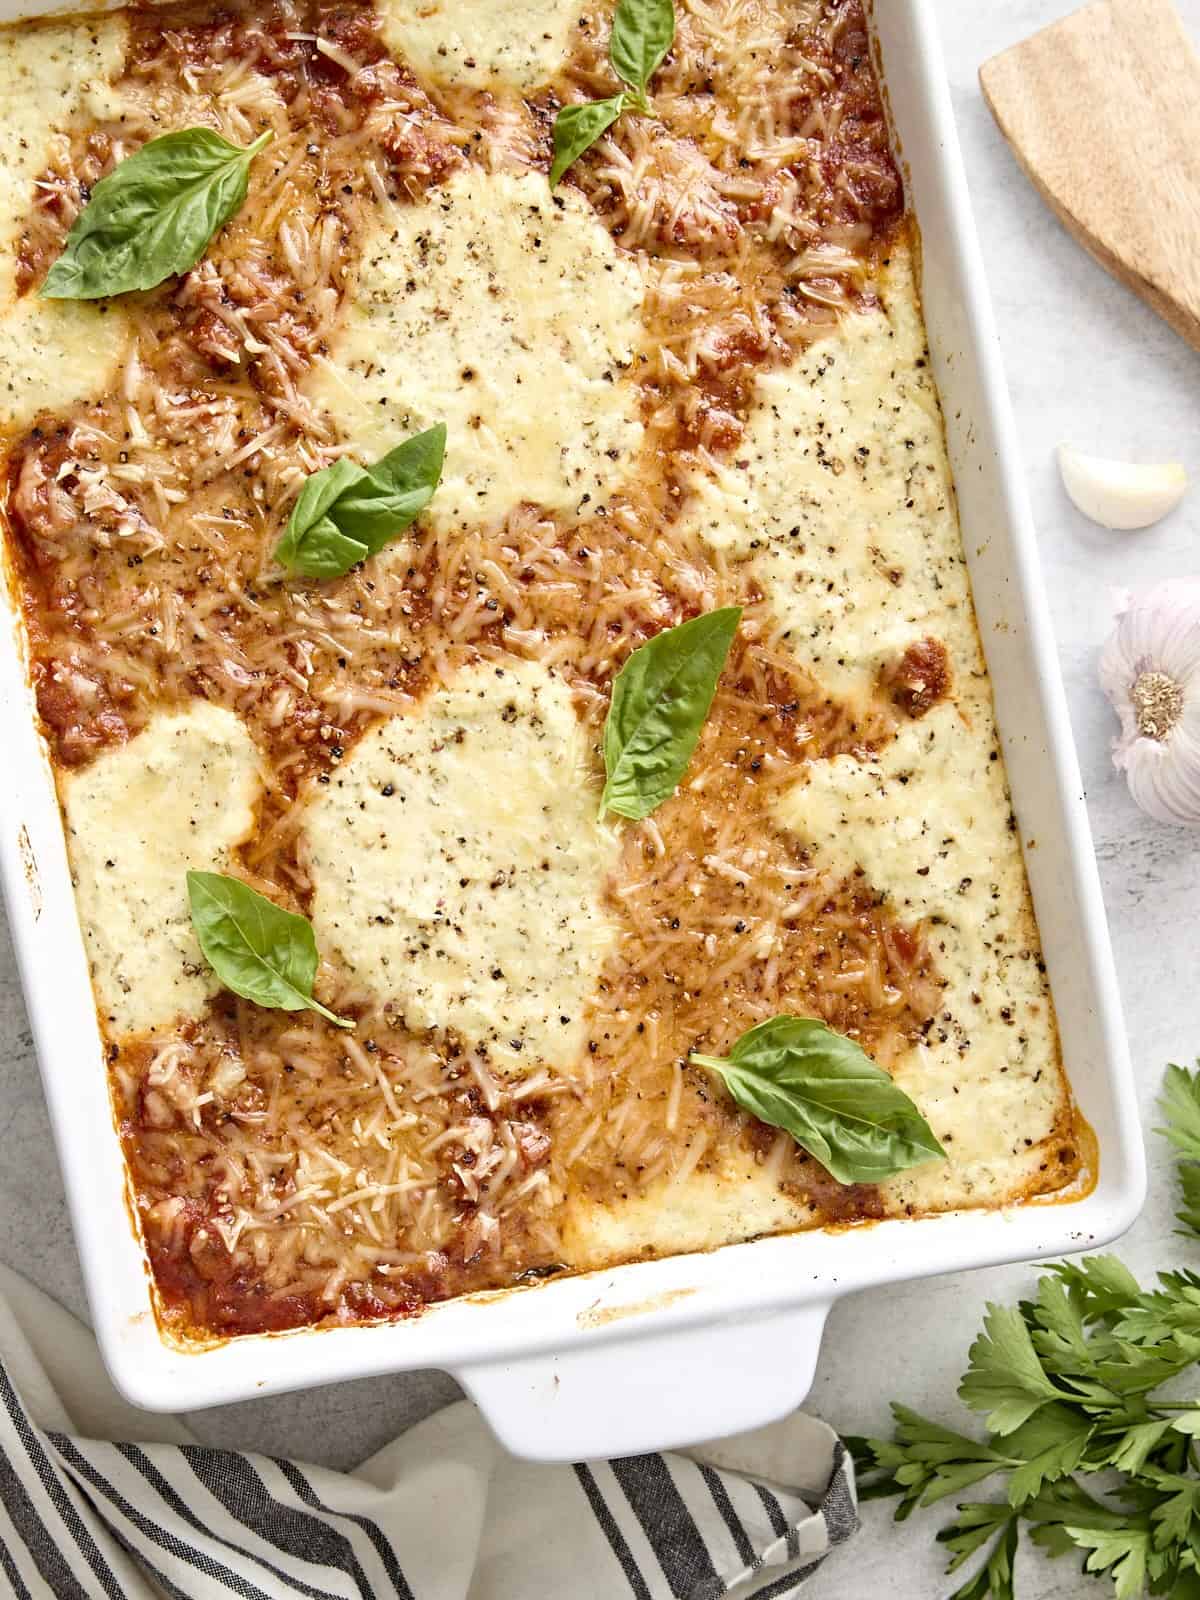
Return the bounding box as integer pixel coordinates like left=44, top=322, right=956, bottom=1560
left=187, top=872, right=354, bottom=1027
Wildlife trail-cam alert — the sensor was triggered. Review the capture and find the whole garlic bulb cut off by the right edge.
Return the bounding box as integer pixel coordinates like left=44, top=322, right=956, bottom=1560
left=1099, top=578, right=1200, bottom=827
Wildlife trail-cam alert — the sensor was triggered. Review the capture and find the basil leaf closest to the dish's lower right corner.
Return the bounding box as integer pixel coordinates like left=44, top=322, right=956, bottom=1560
left=690, top=1016, right=946, bottom=1184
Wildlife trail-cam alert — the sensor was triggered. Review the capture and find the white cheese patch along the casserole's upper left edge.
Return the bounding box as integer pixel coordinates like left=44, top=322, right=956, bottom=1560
left=0, top=18, right=128, bottom=429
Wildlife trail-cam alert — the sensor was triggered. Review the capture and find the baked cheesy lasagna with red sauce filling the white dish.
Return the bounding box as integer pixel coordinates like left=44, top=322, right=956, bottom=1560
left=0, top=0, right=1085, bottom=1341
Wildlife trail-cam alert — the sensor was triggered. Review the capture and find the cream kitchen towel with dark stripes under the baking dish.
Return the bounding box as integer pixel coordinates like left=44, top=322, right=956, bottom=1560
left=0, top=1269, right=858, bottom=1600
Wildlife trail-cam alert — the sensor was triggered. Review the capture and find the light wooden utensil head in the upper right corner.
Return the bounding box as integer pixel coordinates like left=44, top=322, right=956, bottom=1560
left=979, top=0, right=1200, bottom=350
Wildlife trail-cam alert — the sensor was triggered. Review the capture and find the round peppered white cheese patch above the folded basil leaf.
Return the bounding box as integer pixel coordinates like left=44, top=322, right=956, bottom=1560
left=309, top=168, right=642, bottom=526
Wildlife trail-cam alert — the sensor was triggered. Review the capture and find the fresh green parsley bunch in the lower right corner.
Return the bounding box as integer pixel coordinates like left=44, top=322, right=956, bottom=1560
left=850, top=1066, right=1200, bottom=1600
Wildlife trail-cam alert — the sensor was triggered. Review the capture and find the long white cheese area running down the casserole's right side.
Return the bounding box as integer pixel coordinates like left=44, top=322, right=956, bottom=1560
left=739, top=250, right=1062, bottom=1206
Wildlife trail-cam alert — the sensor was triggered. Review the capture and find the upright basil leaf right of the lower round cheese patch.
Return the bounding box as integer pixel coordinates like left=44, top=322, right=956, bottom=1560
left=600, top=606, right=742, bottom=822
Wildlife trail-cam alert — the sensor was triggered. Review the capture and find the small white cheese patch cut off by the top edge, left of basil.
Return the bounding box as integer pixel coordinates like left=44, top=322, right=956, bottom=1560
left=379, top=0, right=582, bottom=90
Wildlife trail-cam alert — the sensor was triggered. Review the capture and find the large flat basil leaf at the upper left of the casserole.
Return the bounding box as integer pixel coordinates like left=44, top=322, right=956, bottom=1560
left=38, top=128, right=272, bottom=299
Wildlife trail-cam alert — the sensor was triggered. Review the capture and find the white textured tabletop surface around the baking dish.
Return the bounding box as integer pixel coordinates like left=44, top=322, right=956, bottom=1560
left=0, top=0, right=1200, bottom=1600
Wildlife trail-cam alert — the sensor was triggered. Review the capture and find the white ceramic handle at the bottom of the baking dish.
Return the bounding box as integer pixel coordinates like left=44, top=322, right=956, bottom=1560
left=454, top=1302, right=829, bottom=1461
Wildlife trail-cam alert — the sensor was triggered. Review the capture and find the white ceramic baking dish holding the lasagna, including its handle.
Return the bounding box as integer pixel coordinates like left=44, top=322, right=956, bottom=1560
left=0, top=0, right=1146, bottom=1459
